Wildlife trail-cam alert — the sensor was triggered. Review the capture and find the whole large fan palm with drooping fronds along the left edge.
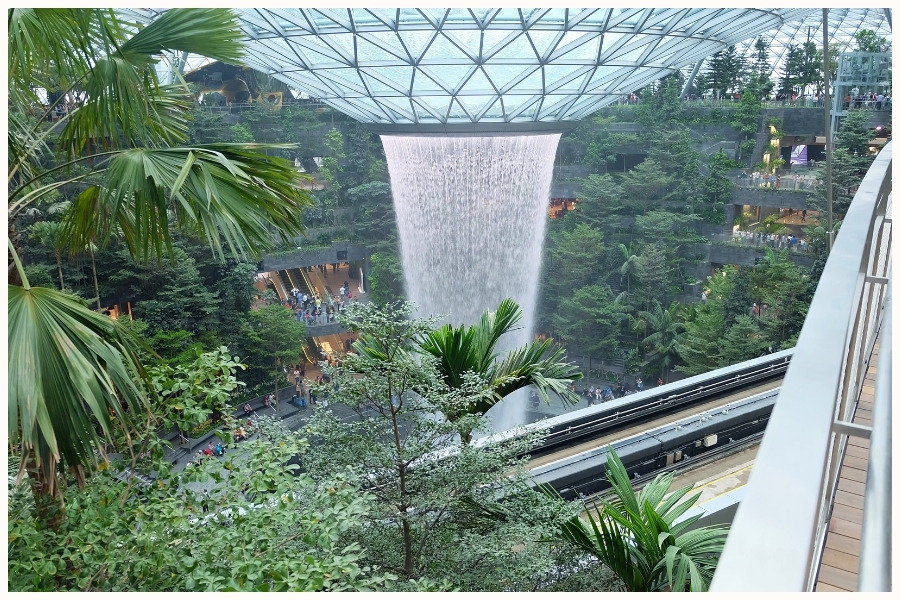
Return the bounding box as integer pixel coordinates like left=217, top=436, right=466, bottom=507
left=7, top=8, right=310, bottom=526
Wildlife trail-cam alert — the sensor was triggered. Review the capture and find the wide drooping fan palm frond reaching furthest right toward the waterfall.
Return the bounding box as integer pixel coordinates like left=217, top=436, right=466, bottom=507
left=64, top=144, right=311, bottom=259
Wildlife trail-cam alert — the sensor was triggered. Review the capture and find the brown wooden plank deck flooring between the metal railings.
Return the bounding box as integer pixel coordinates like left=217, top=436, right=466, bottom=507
left=815, top=339, right=879, bottom=592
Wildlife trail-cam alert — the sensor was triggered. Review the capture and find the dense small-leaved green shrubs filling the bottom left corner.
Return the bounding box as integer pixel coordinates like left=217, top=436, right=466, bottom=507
left=7, top=436, right=393, bottom=592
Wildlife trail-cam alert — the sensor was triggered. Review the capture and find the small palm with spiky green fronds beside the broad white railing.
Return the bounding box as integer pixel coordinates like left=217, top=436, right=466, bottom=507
left=545, top=447, right=728, bottom=592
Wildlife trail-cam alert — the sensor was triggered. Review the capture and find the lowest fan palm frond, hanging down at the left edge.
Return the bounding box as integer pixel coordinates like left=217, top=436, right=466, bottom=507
left=7, top=285, right=152, bottom=488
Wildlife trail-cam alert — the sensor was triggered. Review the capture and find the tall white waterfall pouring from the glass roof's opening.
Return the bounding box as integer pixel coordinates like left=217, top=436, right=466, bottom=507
left=381, top=134, right=560, bottom=430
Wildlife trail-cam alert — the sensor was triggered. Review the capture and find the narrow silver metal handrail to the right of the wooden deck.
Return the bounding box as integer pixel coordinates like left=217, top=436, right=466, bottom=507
left=858, top=286, right=893, bottom=592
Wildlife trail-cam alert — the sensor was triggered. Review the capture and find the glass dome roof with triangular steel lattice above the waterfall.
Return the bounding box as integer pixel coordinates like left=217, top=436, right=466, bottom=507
left=125, top=8, right=890, bottom=125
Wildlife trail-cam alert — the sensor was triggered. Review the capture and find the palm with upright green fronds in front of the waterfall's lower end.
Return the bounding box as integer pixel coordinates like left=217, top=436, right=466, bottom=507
left=419, top=298, right=581, bottom=443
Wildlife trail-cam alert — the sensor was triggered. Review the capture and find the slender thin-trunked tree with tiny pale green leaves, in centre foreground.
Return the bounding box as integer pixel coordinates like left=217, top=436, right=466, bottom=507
left=303, top=304, right=558, bottom=589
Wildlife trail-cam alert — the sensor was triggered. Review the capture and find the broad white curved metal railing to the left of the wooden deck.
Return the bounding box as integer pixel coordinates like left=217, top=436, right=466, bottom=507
left=710, top=142, right=892, bottom=592
